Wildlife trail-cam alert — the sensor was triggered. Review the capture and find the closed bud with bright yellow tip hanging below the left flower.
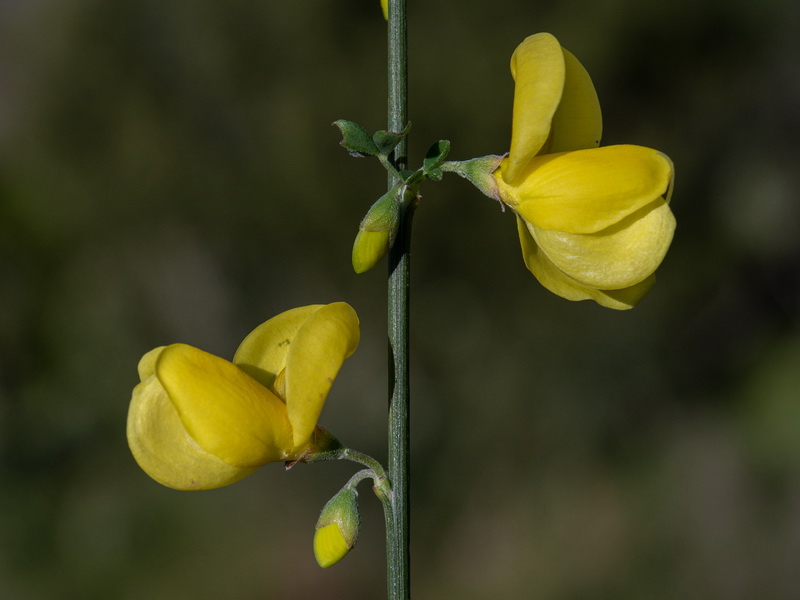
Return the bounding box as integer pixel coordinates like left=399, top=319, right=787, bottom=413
left=314, top=488, right=361, bottom=569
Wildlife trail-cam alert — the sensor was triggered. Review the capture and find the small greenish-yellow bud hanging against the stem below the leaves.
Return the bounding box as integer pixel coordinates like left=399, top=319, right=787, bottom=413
left=352, top=190, right=400, bottom=273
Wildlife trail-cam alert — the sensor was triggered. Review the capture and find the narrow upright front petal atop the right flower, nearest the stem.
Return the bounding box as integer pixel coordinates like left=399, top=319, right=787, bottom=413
left=505, top=33, right=565, bottom=184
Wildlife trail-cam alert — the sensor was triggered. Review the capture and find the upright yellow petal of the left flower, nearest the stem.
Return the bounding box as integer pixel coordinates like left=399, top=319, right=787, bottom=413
left=284, top=302, right=360, bottom=447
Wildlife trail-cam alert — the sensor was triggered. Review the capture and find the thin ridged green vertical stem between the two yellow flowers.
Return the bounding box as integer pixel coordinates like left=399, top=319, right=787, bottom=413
left=386, top=0, right=416, bottom=600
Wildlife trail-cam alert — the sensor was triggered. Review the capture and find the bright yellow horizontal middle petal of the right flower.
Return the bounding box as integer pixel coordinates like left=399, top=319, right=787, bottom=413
left=504, top=146, right=673, bottom=233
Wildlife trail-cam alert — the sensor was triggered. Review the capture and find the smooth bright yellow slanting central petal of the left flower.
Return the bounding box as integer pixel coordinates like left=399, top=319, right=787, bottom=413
left=156, top=344, right=294, bottom=468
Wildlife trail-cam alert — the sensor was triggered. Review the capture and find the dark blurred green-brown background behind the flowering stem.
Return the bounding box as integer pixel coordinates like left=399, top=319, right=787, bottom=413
left=0, top=0, right=800, bottom=600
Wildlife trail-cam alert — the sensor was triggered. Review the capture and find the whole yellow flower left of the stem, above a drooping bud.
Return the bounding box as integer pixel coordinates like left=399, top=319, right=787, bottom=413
left=127, top=302, right=359, bottom=490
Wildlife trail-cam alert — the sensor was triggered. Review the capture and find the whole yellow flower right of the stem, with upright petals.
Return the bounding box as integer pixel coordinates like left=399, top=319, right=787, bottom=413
left=494, top=33, right=675, bottom=309
